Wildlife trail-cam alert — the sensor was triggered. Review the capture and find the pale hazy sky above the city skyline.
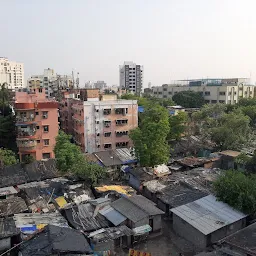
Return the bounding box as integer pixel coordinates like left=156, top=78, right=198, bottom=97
left=0, top=0, right=256, bottom=87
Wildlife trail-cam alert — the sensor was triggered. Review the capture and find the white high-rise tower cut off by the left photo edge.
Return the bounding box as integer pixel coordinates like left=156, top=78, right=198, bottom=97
left=0, top=57, right=25, bottom=90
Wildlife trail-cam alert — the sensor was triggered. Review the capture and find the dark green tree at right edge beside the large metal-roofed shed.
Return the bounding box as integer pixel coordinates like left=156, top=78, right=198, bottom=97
left=214, top=170, right=256, bottom=214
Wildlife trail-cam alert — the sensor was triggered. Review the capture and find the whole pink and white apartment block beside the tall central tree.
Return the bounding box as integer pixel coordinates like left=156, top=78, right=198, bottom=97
left=60, top=89, right=138, bottom=153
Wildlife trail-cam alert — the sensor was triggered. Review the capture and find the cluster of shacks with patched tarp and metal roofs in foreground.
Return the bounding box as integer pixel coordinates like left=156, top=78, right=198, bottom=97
left=0, top=148, right=256, bottom=256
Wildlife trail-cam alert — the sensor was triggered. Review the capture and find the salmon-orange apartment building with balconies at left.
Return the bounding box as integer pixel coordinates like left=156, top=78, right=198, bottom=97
left=14, top=88, right=59, bottom=161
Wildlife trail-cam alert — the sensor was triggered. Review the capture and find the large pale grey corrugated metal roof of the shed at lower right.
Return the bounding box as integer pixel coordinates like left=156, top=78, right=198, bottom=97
left=171, top=195, right=246, bottom=235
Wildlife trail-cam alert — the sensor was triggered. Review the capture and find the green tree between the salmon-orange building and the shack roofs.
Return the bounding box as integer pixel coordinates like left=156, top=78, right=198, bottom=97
left=54, top=131, right=105, bottom=183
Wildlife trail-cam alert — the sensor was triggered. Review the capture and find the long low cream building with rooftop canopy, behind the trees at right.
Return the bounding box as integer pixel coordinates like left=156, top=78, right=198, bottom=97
left=151, top=78, right=255, bottom=104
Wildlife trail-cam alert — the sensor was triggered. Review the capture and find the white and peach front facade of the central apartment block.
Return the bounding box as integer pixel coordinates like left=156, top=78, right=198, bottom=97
left=83, top=96, right=138, bottom=153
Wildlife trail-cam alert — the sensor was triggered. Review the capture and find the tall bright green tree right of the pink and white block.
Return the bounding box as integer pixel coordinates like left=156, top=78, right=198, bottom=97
left=130, top=104, right=170, bottom=166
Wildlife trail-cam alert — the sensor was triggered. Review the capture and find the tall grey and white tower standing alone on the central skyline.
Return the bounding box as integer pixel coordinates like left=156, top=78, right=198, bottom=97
left=119, top=62, right=143, bottom=95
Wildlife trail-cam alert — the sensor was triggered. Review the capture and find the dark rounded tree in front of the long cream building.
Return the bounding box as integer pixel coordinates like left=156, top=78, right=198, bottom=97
left=172, top=91, right=204, bottom=108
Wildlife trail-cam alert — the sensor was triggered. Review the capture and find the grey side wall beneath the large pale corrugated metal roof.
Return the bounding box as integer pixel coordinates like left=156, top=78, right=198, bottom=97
left=173, top=214, right=207, bottom=249
